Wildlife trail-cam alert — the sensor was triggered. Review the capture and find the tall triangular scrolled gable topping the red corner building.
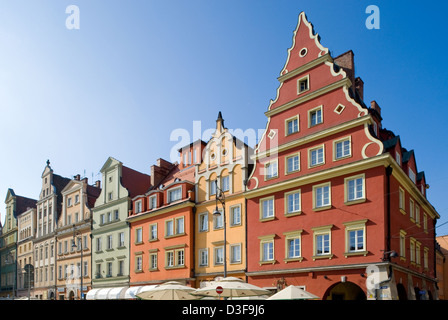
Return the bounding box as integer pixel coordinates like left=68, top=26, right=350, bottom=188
left=248, top=12, right=384, bottom=190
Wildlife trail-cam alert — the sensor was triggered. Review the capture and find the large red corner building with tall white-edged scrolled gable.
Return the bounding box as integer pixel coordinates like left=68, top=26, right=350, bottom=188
left=245, top=12, right=439, bottom=299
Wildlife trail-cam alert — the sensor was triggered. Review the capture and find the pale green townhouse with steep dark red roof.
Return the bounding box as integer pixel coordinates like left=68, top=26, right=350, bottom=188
left=92, top=157, right=151, bottom=294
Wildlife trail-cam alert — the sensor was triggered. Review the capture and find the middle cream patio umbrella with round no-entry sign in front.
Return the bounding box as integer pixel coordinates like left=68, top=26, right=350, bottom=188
left=193, top=277, right=269, bottom=297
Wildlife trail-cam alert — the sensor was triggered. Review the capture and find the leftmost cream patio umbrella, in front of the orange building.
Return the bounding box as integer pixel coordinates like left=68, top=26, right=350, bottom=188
left=137, top=281, right=198, bottom=300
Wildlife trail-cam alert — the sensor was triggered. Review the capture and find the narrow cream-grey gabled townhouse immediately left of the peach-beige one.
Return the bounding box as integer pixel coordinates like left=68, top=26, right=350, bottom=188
left=34, top=161, right=70, bottom=300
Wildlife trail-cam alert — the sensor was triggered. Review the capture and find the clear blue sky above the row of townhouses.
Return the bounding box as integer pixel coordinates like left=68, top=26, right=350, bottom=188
left=0, top=0, right=448, bottom=235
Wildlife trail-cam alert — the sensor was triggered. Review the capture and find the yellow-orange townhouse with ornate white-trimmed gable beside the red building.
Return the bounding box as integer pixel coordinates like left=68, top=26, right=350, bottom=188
left=195, top=113, right=252, bottom=288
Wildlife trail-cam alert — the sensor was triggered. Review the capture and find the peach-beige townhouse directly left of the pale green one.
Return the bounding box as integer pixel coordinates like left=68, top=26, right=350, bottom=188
left=56, top=175, right=101, bottom=300
